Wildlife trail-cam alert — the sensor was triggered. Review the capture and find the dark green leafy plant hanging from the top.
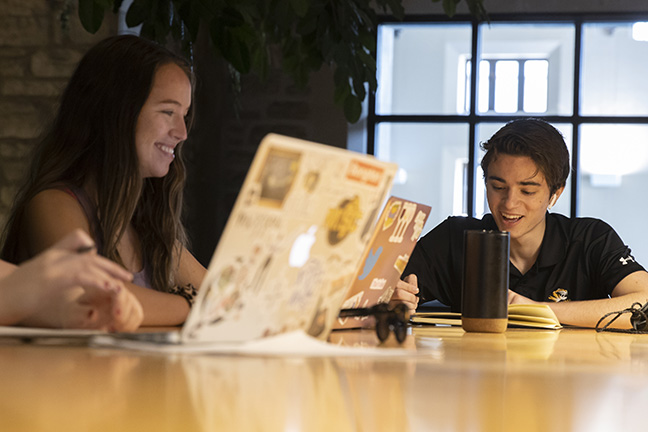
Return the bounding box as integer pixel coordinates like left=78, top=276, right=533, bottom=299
left=78, top=0, right=486, bottom=123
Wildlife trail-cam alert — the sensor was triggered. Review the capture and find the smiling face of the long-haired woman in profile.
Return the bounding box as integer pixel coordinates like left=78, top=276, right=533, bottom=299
left=135, top=63, right=191, bottom=178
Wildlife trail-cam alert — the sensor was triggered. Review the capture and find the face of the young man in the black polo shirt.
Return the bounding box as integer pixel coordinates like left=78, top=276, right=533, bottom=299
left=486, top=154, right=562, bottom=242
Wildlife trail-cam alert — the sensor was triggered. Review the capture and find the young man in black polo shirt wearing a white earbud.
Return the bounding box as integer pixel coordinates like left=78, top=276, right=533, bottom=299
left=392, top=119, right=648, bottom=328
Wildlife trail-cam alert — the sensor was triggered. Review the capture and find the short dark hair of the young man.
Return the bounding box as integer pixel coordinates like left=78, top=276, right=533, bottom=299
left=481, top=118, right=570, bottom=195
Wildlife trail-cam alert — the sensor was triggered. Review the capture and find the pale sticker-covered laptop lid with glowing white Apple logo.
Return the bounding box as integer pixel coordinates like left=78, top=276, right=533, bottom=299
left=181, top=134, right=397, bottom=342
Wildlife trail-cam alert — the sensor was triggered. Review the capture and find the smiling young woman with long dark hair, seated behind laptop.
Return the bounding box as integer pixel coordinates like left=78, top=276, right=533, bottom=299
left=2, top=36, right=205, bottom=325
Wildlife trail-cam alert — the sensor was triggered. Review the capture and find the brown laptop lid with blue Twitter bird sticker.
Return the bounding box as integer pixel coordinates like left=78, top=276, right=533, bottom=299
left=333, top=196, right=431, bottom=329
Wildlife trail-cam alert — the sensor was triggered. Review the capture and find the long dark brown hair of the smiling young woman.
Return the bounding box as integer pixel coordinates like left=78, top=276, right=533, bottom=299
left=2, top=35, right=194, bottom=291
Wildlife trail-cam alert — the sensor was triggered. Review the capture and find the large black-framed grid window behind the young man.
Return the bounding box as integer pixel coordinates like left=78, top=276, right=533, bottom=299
left=366, top=15, right=648, bottom=264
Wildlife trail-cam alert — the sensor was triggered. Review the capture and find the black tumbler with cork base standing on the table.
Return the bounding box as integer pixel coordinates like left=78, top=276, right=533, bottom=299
left=461, top=230, right=510, bottom=333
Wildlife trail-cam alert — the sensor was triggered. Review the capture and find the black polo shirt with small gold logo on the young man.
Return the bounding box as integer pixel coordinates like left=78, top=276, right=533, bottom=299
left=403, top=213, right=644, bottom=311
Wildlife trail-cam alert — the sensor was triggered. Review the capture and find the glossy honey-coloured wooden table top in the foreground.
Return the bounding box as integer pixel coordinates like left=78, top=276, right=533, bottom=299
left=0, top=327, right=648, bottom=432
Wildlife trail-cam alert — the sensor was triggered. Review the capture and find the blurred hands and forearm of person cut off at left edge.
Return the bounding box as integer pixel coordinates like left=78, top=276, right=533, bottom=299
left=0, top=230, right=142, bottom=331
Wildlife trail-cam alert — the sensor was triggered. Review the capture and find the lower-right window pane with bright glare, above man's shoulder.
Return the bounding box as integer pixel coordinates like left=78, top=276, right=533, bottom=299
left=579, top=124, right=648, bottom=265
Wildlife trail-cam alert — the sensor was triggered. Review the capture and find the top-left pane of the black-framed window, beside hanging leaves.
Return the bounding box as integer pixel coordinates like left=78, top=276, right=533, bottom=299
left=376, top=23, right=472, bottom=115
